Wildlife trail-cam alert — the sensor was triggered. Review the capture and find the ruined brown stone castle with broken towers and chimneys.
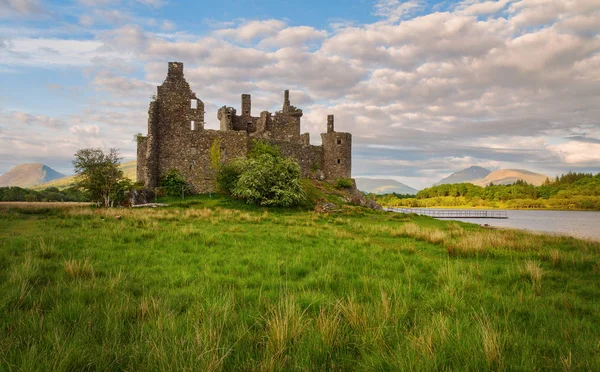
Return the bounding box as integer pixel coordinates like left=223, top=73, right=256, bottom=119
left=137, top=62, right=352, bottom=193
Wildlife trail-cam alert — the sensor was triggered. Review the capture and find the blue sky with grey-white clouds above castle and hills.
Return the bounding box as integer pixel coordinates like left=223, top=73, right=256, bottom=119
left=0, top=0, right=600, bottom=188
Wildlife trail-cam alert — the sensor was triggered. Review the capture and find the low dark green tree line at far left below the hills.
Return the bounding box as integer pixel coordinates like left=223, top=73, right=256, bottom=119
left=0, top=186, right=90, bottom=202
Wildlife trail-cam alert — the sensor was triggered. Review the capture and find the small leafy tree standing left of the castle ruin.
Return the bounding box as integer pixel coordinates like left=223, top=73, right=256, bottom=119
left=73, top=148, right=131, bottom=207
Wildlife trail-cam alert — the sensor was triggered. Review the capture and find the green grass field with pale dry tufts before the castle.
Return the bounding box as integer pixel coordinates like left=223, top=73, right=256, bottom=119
left=0, top=196, right=600, bottom=371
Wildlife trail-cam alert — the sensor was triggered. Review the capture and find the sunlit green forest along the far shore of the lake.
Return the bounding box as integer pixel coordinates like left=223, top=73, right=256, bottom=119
left=375, top=172, right=600, bottom=210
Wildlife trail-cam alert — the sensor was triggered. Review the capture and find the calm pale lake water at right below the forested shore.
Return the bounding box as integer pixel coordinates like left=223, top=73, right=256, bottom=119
left=438, top=210, right=600, bottom=241
